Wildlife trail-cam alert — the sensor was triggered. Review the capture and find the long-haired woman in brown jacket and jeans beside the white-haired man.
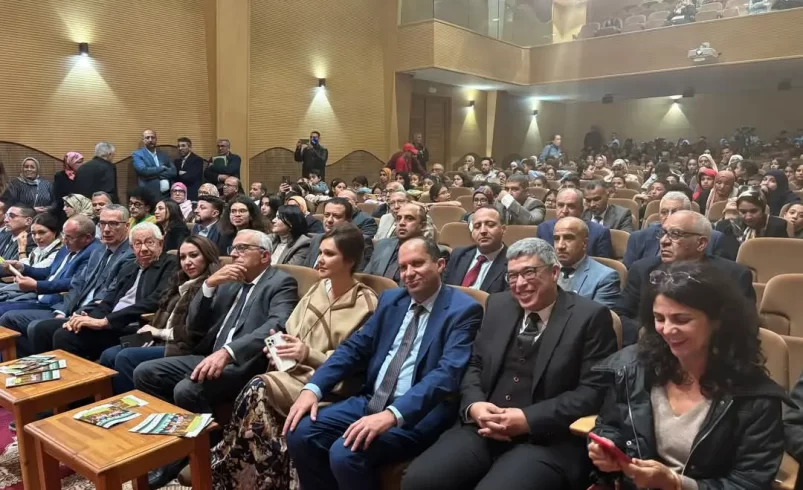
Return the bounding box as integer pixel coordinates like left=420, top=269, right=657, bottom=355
left=99, top=236, right=220, bottom=395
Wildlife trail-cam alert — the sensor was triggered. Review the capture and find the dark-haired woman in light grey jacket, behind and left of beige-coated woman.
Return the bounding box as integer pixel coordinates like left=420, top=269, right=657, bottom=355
left=270, top=206, right=311, bottom=265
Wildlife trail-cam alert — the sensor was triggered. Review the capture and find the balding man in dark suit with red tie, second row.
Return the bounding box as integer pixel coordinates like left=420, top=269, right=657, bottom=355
left=443, top=206, right=508, bottom=294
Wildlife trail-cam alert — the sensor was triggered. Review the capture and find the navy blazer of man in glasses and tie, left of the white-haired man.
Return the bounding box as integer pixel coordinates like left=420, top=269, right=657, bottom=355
left=52, top=240, right=134, bottom=316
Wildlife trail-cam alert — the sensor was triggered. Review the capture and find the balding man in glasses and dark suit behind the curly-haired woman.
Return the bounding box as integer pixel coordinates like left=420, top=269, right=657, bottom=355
left=613, top=211, right=758, bottom=345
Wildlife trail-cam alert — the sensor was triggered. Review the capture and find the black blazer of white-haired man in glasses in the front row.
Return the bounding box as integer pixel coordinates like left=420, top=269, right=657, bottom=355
left=89, top=253, right=178, bottom=335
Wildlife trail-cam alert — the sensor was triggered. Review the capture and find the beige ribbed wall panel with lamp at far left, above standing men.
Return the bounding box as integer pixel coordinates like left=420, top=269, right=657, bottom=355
left=0, top=0, right=214, bottom=161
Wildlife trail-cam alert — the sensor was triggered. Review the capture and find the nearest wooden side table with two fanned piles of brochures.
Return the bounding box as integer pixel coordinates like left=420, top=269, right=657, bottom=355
left=25, top=390, right=217, bottom=490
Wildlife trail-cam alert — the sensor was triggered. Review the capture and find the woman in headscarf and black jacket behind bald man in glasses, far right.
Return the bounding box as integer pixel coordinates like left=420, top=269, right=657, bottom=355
left=715, top=186, right=789, bottom=257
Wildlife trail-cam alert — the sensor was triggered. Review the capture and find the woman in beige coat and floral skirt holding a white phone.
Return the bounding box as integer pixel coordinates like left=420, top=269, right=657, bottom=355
left=203, top=223, right=377, bottom=490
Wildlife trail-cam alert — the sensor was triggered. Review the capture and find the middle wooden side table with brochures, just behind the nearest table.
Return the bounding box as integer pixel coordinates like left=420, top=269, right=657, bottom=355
left=0, top=350, right=117, bottom=490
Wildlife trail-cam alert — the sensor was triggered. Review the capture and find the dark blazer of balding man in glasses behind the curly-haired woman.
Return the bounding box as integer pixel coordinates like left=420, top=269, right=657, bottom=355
left=613, top=256, right=758, bottom=345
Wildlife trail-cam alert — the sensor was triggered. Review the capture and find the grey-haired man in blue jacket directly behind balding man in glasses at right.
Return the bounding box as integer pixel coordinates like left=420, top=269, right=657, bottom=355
left=622, top=191, right=736, bottom=269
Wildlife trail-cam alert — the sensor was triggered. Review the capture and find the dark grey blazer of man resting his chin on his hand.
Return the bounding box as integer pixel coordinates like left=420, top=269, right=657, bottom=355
left=187, top=267, right=298, bottom=374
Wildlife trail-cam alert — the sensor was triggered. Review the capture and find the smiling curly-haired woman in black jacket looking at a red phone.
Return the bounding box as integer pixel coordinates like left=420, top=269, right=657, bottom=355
left=588, top=262, right=792, bottom=490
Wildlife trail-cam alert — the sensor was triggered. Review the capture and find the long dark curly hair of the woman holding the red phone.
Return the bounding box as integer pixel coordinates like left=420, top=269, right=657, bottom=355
left=638, top=262, right=766, bottom=398
